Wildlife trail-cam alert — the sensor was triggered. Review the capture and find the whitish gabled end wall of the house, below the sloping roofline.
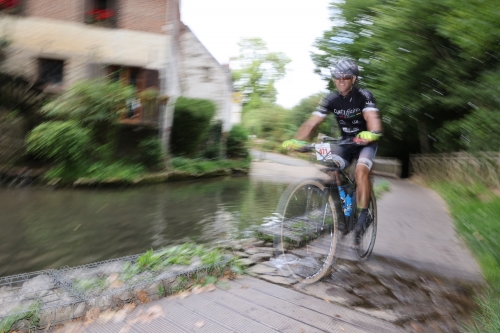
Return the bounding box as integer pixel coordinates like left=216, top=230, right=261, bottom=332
left=179, top=26, right=232, bottom=132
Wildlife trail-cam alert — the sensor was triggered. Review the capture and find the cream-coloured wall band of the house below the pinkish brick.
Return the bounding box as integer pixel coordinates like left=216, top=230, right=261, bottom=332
left=0, top=17, right=169, bottom=89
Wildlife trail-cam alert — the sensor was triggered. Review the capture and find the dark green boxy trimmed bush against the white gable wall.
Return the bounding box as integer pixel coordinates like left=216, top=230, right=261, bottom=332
left=171, top=97, right=216, bottom=157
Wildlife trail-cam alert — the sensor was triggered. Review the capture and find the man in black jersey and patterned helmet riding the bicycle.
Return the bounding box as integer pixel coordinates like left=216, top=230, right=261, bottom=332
left=283, top=59, right=382, bottom=246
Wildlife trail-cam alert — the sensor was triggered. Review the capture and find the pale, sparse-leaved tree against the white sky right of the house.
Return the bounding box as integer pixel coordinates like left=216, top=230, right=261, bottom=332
left=232, top=38, right=291, bottom=111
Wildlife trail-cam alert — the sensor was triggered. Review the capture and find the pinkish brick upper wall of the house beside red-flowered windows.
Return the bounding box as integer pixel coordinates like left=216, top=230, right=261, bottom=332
left=23, top=0, right=167, bottom=33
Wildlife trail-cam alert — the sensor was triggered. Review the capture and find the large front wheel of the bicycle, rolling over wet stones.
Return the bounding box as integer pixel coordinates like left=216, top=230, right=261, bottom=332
left=275, top=179, right=340, bottom=283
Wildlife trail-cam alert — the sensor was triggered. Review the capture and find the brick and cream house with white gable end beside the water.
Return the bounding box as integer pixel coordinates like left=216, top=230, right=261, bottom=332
left=0, top=0, right=232, bottom=131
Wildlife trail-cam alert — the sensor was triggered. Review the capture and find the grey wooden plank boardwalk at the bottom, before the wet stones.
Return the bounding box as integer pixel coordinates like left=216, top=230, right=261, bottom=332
left=75, top=277, right=403, bottom=333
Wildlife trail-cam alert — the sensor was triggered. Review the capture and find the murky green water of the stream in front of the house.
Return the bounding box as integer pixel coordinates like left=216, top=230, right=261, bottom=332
left=0, top=178, right=286, bottom=276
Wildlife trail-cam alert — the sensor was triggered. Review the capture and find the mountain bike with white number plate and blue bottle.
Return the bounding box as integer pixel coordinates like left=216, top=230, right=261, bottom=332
left=274, top=137, right=377, bottom=283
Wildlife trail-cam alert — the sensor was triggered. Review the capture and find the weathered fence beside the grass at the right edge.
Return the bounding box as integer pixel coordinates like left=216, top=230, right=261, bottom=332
left=410, top=152, right=500, bottom=186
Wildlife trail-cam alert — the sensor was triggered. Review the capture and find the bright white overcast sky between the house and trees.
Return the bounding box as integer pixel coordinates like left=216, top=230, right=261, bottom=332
left=181, top=0, right=331, bottom=108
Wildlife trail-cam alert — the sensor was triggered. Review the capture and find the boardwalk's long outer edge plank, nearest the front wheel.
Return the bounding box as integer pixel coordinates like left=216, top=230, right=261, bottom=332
left=233, top=277, right=402, bottom=333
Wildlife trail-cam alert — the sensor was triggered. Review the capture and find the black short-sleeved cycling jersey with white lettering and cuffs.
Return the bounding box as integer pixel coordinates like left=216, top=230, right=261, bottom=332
left=313, top=87, right=378, bottom=138
